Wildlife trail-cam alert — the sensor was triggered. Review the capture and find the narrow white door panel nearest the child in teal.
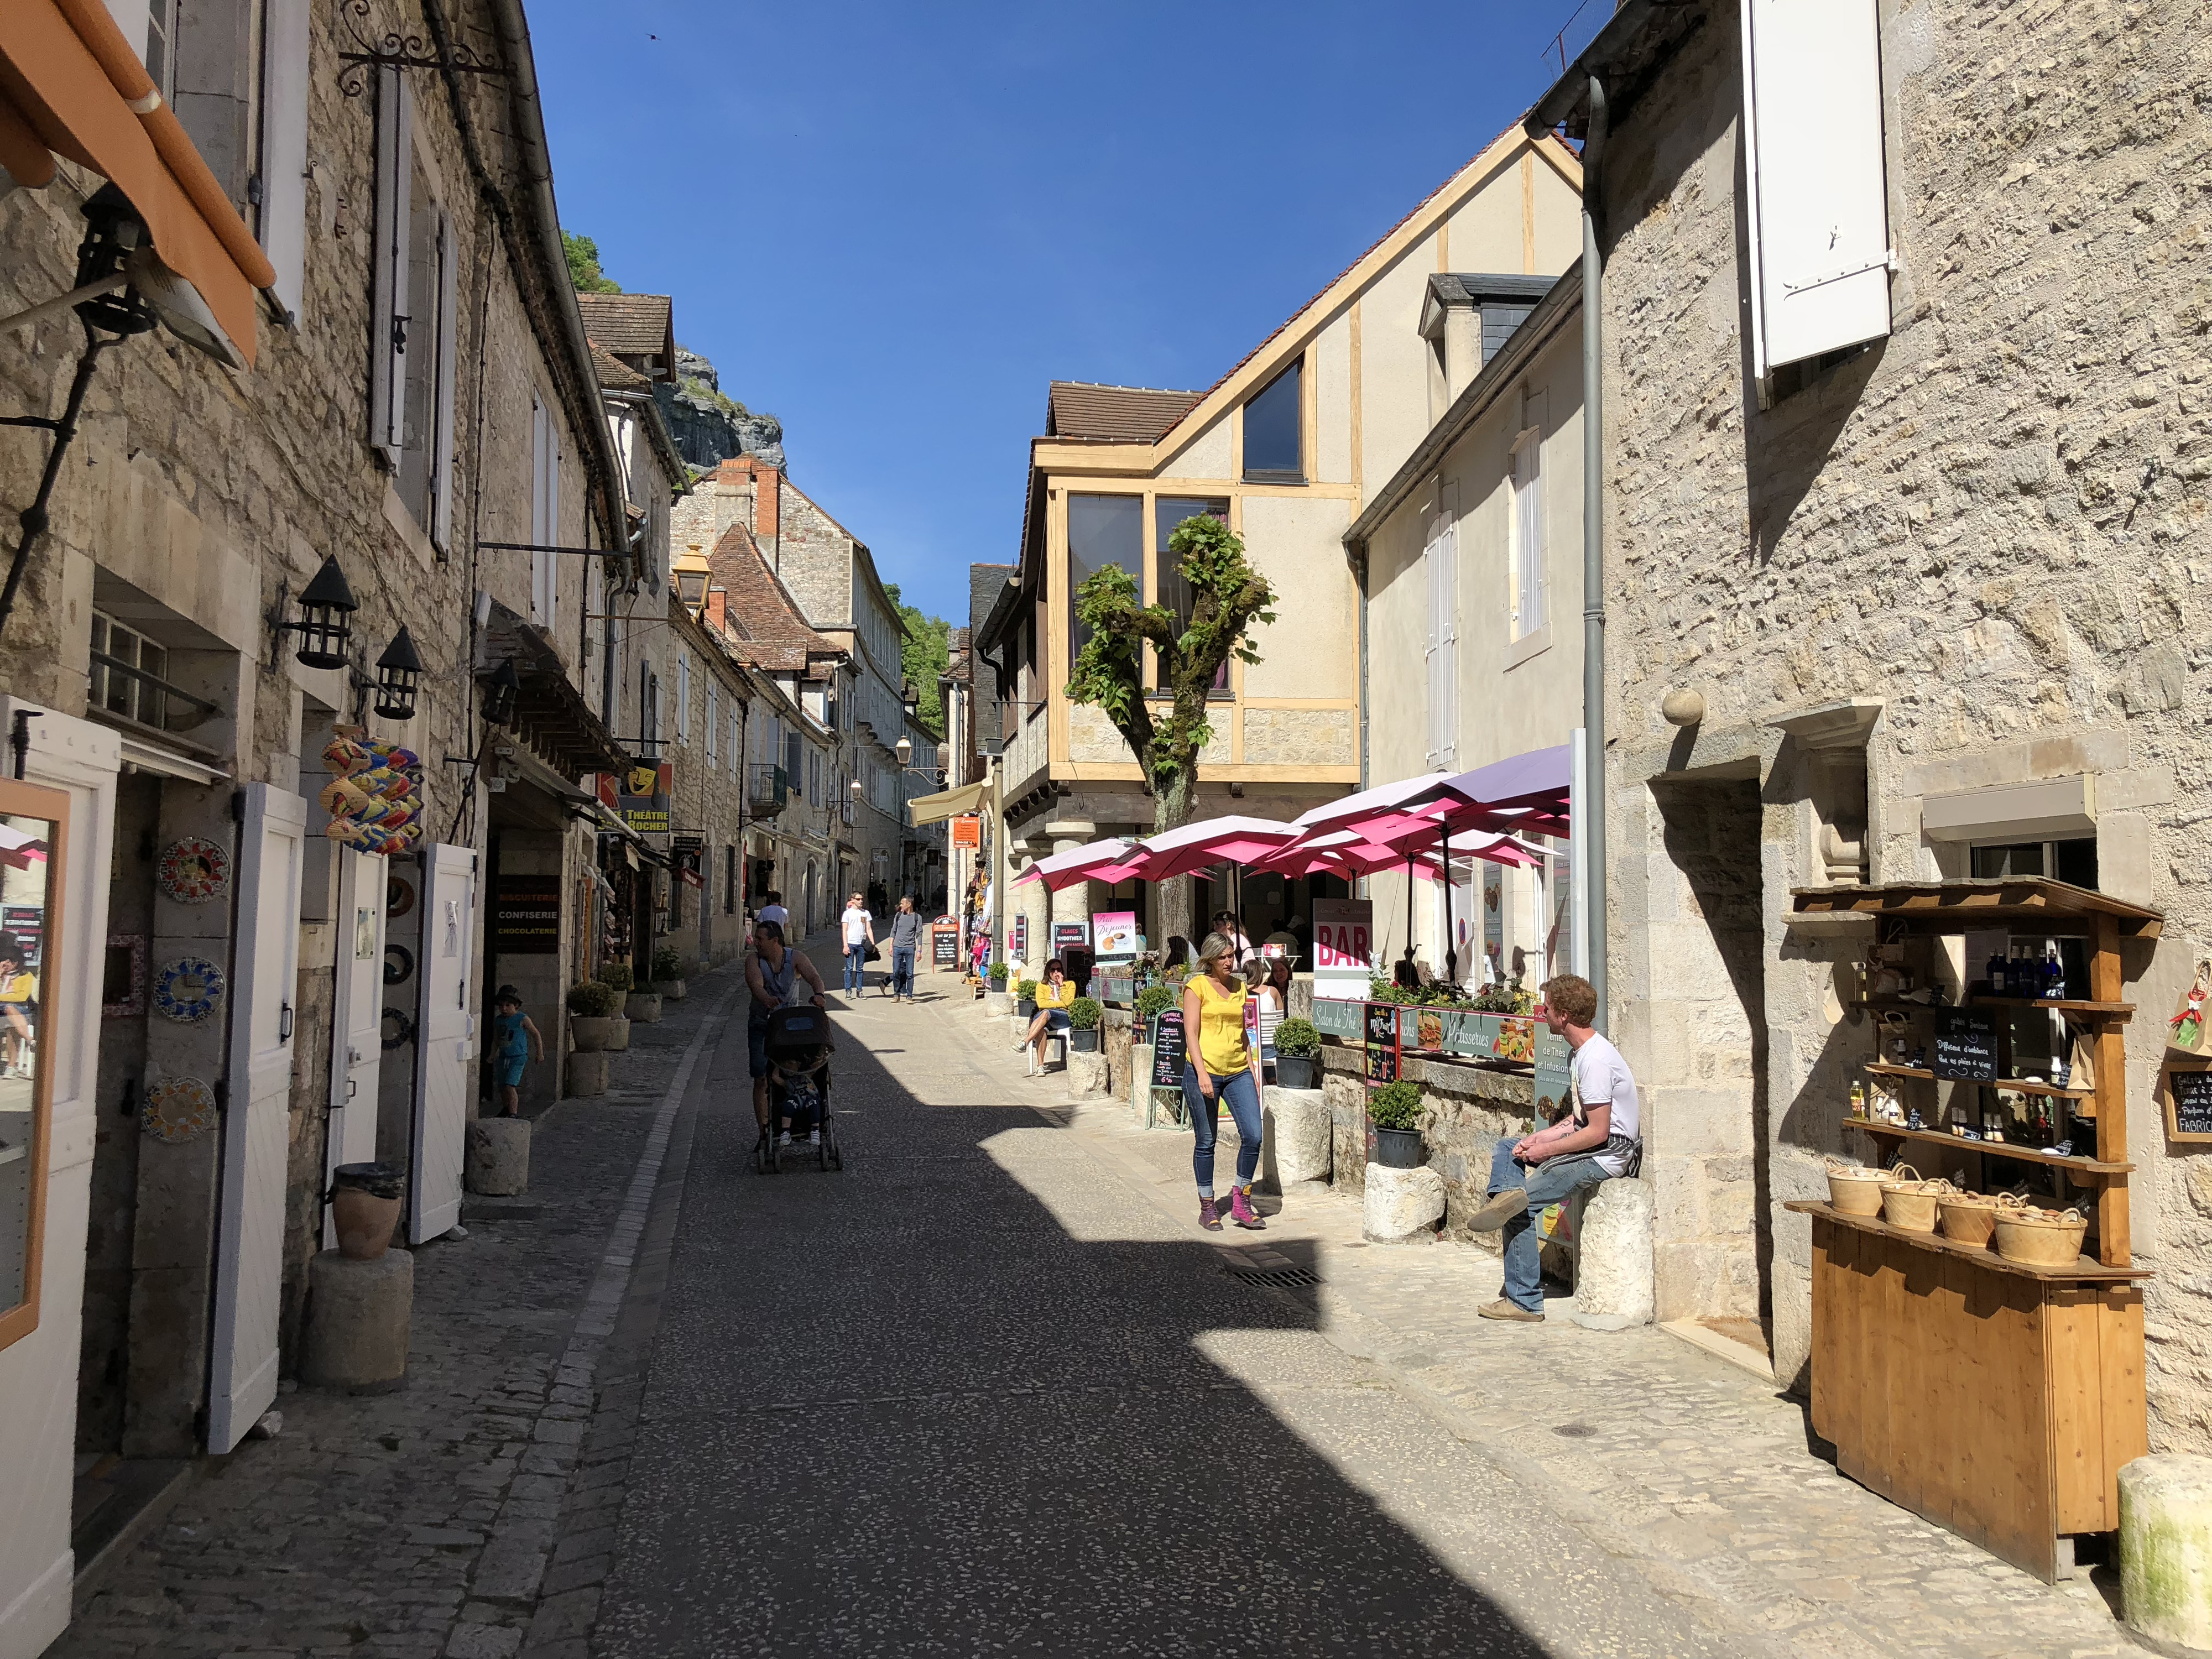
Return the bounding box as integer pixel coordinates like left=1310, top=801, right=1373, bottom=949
left=407, top=843, right=476, bottom=1243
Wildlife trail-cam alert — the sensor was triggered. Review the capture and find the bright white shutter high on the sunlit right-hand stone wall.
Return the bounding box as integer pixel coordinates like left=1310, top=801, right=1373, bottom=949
left=1743, top=0, right=1896, bottom=378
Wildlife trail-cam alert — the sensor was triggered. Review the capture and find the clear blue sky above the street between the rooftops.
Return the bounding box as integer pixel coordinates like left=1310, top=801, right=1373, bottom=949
left=529, top=0, right=1610, bottom=626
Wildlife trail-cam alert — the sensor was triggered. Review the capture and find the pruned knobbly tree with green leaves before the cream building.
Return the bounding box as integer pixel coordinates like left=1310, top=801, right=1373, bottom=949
left=1068, top=513, right=1274, bottom=940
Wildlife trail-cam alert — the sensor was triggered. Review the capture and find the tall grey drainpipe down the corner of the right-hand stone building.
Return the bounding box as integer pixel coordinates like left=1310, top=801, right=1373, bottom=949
left=1584, top=75, right=1606, bottom=1031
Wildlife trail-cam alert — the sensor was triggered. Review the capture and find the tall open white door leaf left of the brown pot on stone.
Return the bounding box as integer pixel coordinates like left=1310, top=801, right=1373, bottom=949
left=208, top=783, right=307, bottom=1453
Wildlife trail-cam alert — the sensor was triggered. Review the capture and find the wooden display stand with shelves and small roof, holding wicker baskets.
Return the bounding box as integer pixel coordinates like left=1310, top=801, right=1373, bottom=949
left=1783, top=878, right=2159, bottom=1582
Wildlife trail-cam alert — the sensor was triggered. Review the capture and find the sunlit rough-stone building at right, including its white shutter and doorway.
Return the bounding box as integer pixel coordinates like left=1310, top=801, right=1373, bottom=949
left=1531, top=0, right=2212, bottom=1451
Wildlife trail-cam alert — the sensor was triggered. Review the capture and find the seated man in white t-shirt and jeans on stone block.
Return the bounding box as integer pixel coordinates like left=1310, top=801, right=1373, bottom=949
left=1469, top=973, right=1644, bottom=1323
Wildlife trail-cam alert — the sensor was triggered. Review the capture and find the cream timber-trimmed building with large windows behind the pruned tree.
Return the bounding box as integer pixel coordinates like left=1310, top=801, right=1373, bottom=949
left=973, top=128, right=1582, bottom=956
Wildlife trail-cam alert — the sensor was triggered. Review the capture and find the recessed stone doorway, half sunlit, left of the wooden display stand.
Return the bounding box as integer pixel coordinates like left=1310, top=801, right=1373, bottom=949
left=1644, top=776, right=1774, bottom=1352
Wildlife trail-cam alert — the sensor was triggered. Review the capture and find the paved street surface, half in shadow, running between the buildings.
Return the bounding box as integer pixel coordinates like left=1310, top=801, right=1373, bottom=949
left=55, top=956, right=2132, bottom=1659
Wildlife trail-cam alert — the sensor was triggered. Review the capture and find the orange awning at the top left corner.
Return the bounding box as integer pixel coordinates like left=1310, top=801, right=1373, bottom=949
left=0, top=0, right=276, bottom=363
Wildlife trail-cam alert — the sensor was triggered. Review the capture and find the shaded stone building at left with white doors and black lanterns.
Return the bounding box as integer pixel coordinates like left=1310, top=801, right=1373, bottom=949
left=0, top=0, right=628, bottom=1652
